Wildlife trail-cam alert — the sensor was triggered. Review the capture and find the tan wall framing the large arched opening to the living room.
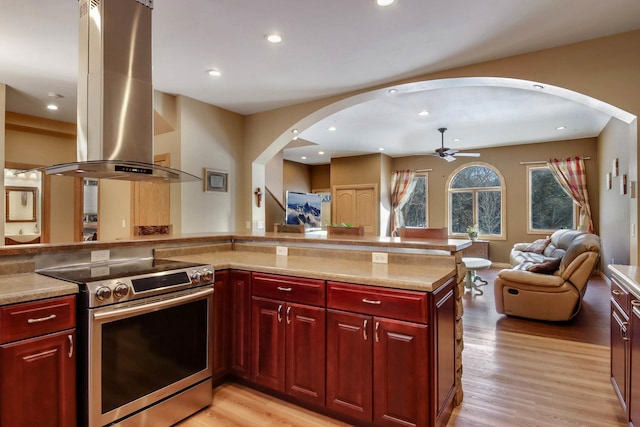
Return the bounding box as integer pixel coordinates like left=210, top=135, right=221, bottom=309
left=245, top=31, right=640, bottom=264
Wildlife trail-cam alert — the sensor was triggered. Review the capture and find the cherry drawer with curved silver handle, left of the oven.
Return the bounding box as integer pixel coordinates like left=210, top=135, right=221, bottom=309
left=0, top=296, right=76, bottom=343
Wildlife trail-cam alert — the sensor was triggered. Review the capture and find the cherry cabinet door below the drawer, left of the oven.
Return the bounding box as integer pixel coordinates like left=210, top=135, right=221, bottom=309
left=0, top=330, right=76, bottom=427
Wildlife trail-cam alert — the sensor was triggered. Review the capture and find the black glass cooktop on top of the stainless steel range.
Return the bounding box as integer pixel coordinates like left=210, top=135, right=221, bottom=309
left=36, top=258, right=202, bottom=284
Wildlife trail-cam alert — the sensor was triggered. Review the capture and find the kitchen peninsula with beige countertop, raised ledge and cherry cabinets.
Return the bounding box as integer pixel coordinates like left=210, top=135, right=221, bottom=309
left=0, top=233, right=470, bottom=425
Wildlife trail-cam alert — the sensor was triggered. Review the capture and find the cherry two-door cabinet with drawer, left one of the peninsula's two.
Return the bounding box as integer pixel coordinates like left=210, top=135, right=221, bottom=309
left=251, top=273, right=325, bottom=406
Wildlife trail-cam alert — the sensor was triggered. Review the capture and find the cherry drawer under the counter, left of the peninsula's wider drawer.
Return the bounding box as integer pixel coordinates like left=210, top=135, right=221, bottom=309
left=252, top=273, right=325, bottom=307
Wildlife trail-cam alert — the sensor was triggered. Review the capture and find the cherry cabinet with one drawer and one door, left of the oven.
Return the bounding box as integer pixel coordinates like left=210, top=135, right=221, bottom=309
left=0, top=296, right=76, bottom=427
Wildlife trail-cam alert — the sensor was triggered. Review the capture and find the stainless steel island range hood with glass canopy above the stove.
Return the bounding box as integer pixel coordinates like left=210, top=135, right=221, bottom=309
left=44, top=0, right=200, bottom=182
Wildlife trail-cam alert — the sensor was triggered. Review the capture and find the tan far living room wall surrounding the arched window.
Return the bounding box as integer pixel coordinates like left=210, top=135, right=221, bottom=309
left=393, top=138, right=596, bottom=263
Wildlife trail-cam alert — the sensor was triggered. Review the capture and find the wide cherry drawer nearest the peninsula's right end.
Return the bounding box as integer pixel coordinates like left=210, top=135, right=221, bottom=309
left=327, top=282, right=428, bottom=323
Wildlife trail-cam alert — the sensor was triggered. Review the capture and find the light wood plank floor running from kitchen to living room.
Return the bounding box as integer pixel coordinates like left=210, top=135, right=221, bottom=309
left=179, top=269, right=627, bottom=427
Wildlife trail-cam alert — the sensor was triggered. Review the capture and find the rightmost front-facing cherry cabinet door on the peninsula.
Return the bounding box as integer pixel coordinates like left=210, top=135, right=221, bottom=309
left=373, top=317, right=429, bottom=426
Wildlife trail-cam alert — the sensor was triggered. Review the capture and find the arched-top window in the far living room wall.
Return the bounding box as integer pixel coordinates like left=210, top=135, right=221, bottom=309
left=448, top=163, right=504, bottom=238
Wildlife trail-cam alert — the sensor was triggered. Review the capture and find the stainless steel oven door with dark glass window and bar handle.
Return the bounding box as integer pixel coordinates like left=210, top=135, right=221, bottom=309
left=87, top=286, right=213, bottom=427
